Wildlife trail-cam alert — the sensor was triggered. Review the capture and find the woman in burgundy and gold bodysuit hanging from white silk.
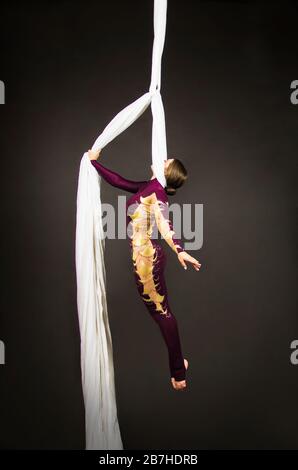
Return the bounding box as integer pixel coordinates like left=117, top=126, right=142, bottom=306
left=88, top=150, right=201, bottom=390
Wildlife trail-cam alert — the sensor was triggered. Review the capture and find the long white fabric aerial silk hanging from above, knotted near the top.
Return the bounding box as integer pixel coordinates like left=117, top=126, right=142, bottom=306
left=75, top=0, right=167, bottom=450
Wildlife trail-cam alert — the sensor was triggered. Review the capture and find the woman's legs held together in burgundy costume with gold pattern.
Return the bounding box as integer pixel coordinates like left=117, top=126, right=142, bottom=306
left=134, top=241, right=186, bottom=381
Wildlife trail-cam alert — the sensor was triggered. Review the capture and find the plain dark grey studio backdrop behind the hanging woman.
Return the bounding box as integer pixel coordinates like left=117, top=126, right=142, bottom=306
left=0, top=0, right=298, bottom=449
